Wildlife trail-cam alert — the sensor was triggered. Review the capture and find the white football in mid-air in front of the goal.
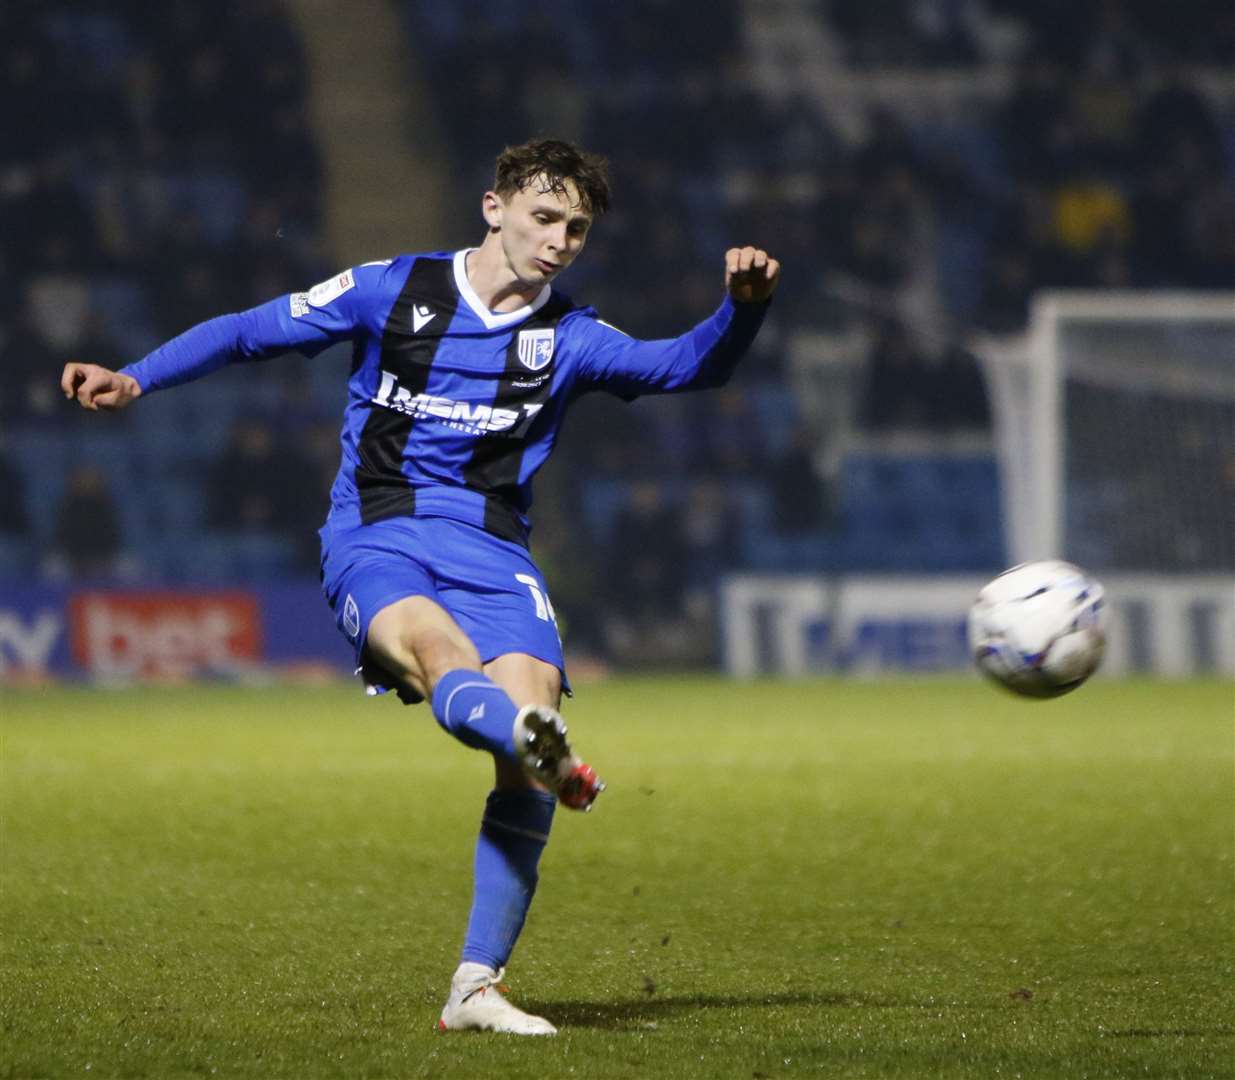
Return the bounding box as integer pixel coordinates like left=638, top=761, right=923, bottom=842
left=969, top=560, right=1107, bottom=698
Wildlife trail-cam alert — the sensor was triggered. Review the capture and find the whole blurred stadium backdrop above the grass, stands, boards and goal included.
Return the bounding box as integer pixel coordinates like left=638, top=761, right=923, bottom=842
left=0, top=0, right=1235, bottom=678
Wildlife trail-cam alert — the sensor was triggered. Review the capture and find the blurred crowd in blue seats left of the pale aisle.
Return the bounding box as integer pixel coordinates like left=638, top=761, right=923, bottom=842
left=0, top=0, right=337, bottom=580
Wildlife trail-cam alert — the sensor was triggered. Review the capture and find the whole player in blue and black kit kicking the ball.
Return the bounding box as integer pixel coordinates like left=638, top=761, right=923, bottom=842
left=61, top=140, right=779, bottom=1034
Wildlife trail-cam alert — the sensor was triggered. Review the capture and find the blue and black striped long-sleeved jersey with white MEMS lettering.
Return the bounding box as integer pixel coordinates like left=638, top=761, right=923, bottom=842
left=124, top=251, right=767, bottom=544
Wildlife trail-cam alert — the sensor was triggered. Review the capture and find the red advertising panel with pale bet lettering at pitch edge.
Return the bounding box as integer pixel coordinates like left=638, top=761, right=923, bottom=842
left=68, top=592, right=262, bottom=678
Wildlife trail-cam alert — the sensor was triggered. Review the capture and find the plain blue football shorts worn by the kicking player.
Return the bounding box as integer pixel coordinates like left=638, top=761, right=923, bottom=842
left=320, top=518, right=569, bottom=699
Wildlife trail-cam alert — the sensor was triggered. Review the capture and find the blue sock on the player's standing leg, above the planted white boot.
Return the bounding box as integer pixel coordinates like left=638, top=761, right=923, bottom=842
left=463, top=788, right=557, bottom=970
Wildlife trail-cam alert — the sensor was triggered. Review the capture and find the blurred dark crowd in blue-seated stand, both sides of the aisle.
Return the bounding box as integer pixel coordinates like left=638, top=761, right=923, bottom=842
left=0, top=0, right=1235, bottom=664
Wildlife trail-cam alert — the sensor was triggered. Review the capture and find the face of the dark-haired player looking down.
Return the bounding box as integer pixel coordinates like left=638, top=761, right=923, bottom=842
left=494, top=180, right=592, bottom=285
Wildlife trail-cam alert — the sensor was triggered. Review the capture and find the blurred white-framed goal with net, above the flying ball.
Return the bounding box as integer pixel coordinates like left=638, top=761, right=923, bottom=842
left=974, top=292, right=1235, bottom=576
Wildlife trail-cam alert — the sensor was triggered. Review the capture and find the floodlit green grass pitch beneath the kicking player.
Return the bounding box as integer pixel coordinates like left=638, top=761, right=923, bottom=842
left=0, top=680, right=1235, bottom=1080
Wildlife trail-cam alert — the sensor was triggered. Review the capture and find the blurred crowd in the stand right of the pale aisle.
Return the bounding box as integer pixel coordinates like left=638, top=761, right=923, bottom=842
left=405, top=0, right=1235, bottom=661
